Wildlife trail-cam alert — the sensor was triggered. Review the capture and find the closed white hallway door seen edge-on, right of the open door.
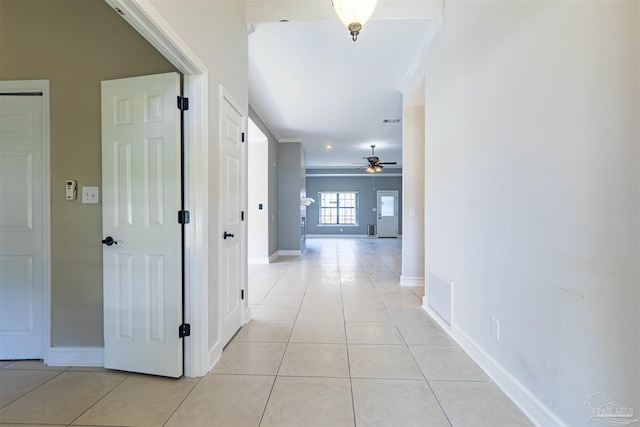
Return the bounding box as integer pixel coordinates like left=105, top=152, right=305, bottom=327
left=220, top=91, right=245, bottom=345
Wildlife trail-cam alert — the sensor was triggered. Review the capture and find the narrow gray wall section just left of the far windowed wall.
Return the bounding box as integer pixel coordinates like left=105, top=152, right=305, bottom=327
left=277, top=142, right=305, bottom=250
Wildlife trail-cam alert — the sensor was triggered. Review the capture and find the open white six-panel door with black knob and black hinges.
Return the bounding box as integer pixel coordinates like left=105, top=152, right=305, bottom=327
left=102, top=73, right=183, bottom=377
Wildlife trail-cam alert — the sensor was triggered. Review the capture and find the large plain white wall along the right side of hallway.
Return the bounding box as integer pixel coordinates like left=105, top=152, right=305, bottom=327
left=425, top=1, right=640, bottom=425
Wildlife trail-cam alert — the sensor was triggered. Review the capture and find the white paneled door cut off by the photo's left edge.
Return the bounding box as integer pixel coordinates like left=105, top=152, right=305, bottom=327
left=0, top=82, right=49, bottom=360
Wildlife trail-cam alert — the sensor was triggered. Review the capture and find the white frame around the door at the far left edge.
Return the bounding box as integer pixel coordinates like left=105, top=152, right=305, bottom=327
left=0, top=80, right=51, bottom=363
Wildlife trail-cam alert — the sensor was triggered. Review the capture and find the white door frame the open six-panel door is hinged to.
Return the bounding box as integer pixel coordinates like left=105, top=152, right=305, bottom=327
left=105, top=0, right=206, bottom=377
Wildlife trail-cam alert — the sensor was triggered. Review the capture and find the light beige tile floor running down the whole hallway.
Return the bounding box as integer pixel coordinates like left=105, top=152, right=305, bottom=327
left=0, top=239, right=531, bottom=427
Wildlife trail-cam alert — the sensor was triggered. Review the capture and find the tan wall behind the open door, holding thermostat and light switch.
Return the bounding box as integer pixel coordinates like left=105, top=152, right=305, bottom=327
left=0, top=0, right=175, bottom=347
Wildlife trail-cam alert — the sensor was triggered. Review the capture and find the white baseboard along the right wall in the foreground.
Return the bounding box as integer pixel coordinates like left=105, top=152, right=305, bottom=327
left=422, top=301, right=566, bottom=426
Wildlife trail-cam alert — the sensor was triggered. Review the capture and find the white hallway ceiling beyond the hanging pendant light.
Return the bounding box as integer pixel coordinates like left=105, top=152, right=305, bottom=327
left=249, top=16, right=435, bottom=169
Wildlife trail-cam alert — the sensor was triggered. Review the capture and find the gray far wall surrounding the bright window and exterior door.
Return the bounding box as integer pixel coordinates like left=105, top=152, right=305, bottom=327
left=307, top=174, right=402, bottom=235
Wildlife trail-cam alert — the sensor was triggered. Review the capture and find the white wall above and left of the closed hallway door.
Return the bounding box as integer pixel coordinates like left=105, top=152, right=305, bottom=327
left=151, top=0, right=248, bottom=367
